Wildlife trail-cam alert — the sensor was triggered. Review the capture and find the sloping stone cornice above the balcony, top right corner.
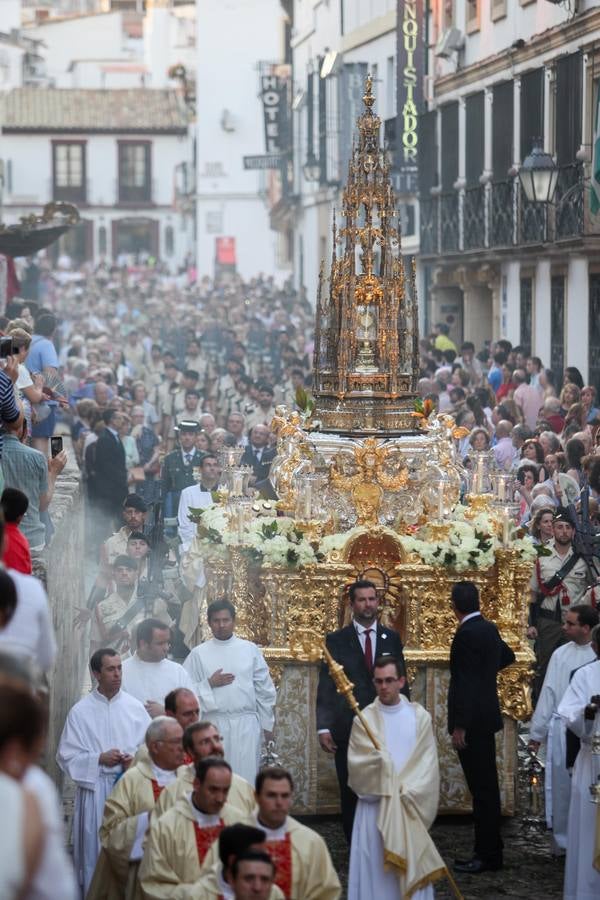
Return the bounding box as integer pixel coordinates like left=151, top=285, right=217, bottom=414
left=434, top=8, right=600, bottom=97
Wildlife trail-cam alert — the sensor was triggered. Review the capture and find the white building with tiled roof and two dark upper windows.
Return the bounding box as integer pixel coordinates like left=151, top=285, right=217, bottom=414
left=0, top=88, right=193, bottom=271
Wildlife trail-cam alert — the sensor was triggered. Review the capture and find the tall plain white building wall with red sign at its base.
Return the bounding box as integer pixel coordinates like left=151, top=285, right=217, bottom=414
left=196, top=0, right=290, bottom=282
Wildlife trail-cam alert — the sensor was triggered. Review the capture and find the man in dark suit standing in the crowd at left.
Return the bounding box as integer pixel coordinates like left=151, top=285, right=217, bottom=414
left=94, top=409, right=127, bottom=529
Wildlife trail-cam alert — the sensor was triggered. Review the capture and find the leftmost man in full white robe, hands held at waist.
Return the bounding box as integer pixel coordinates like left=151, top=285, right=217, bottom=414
left=56, top=649, right=151, bottom=896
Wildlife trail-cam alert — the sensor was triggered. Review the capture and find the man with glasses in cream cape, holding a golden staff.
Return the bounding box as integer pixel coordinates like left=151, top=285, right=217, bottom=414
left=348, top=656, right=446, bottom=900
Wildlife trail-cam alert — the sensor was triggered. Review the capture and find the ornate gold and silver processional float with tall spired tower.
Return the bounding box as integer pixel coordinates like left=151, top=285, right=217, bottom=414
left=184, top=78, right=535, bottom=814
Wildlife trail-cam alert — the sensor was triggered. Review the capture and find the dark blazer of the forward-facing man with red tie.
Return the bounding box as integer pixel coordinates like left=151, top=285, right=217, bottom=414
left=317, top=623, right=408, bottom=745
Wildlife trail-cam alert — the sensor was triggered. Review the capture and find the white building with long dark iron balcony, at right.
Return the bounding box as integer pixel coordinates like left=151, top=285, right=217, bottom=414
left=419, top=0, right=600, bottom=387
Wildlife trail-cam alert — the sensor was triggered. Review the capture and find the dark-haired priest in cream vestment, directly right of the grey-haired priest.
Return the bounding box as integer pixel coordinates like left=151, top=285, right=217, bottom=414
left=155, top=722, right=255, bottom=818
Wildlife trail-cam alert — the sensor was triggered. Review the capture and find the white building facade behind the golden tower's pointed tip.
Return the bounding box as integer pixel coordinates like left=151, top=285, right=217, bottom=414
left=291, top=0, right=418, bottom=303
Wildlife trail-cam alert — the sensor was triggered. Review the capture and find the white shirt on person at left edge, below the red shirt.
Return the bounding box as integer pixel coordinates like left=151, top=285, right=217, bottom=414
left=0, top=569, right=56, bottom=672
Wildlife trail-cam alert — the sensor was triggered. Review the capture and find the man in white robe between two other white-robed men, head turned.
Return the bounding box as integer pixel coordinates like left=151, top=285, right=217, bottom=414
left=123, top=619, right=194, bottom=718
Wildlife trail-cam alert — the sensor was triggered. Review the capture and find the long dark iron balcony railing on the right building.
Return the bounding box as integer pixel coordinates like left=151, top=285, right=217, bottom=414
left=420, top=164, right=600, bottom=256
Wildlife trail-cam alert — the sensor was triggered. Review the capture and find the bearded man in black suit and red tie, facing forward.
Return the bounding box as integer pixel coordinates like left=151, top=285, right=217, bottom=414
left=317, top=581, right=408, bottom=843
